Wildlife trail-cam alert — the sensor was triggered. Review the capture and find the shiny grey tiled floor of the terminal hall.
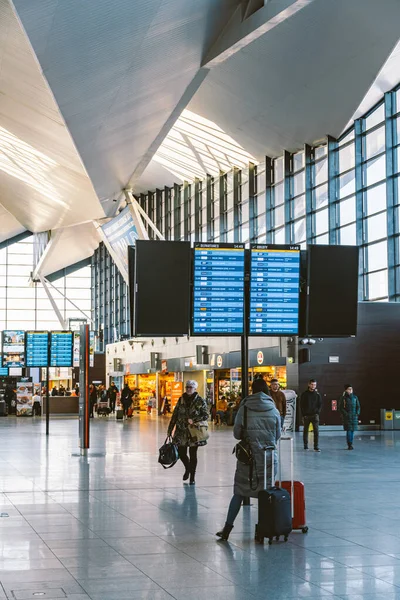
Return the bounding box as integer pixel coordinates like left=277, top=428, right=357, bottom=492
left=0, top=416, right=400, bottom=600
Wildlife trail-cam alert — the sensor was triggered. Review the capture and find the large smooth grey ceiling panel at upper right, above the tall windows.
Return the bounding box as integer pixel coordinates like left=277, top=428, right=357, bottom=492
left=188, top=0, right=400, bottom=159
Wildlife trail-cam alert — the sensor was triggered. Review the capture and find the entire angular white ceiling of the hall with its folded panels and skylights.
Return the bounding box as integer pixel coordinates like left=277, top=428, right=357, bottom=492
left=0, top=0, right=400, bottom=272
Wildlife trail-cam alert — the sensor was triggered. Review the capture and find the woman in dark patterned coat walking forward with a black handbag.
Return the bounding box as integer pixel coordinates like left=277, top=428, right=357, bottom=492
left=168, top=379, right=209, bottom=485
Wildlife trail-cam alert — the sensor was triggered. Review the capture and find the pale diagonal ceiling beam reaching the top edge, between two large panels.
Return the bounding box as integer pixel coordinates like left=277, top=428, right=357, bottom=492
left=202, top=0, right=314, bottom=69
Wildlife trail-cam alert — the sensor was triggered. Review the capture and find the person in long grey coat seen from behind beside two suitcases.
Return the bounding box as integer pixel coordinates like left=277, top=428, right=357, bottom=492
left=216, top=378, right=281, bottom=541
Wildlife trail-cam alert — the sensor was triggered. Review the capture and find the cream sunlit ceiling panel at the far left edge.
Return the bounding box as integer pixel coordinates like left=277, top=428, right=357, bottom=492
left=0, top=0, right=104, bottom=232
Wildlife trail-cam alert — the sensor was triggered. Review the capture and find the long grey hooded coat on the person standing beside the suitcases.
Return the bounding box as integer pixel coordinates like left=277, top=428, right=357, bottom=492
left=233, top=392, right=281, bottom=498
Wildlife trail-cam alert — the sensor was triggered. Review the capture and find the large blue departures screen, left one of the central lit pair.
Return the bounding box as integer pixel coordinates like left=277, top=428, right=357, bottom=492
left=192, top=242, right=245, bottom=335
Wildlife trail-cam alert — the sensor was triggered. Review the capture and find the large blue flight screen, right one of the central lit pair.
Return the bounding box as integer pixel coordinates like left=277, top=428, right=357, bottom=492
left=250, top=244, right=300, bottom=335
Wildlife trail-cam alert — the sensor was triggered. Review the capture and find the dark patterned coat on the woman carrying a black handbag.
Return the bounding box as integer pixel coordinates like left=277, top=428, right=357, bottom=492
left=168, top=392, right=208, bottom=446
